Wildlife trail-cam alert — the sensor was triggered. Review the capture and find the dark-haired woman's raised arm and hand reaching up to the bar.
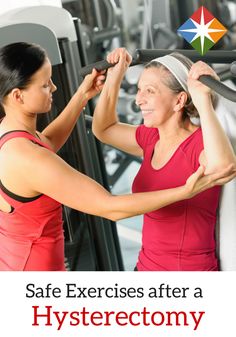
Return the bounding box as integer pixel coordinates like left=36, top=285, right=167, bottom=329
left=42, top=69, right=104, bottom=152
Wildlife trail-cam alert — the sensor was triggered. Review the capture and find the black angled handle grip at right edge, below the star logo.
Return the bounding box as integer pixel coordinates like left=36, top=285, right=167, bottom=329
left=199, top=75, right=236, bottom=102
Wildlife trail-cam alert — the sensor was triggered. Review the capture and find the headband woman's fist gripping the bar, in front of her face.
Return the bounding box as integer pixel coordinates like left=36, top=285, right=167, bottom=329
left=107, top=48, right=132, bottom=82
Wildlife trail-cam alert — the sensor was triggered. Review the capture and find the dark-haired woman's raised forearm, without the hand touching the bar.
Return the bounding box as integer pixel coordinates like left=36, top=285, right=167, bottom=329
left=42, top=90, right=87, bottom=152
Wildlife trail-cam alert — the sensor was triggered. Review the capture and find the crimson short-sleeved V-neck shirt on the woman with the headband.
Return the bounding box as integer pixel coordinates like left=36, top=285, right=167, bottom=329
left=133, top=125, right=220, bottom=271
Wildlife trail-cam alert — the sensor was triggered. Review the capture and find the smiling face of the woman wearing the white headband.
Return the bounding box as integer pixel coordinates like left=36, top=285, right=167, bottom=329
left=136, top=67, right=177, bottom=127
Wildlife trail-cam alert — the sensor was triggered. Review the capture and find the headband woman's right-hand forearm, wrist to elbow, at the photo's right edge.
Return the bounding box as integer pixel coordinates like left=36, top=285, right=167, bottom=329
left=197, top=97, right=235, bottom=172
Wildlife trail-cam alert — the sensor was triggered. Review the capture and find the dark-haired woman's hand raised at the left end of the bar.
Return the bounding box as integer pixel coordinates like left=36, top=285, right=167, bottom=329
left=77, top=68, right=105, bottom=104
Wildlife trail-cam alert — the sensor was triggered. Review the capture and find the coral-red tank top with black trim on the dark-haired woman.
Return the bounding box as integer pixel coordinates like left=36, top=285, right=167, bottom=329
left=0, top=131, right=65, bottom=271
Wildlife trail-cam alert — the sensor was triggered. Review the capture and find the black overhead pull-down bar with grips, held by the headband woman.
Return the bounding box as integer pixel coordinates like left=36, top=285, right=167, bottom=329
left=80, top=49, right=236, bottom=102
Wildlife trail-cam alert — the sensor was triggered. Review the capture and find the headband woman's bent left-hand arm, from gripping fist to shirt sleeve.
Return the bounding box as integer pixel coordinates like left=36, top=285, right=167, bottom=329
left=92, top=48, right=142, bottom=156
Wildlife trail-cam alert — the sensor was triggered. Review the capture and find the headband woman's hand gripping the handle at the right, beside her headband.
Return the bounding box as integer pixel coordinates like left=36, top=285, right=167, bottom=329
left=187, top=61, right=219, bottom=99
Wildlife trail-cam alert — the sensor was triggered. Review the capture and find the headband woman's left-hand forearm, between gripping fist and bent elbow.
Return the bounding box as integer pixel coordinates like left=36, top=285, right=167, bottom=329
left=92, top=83, right=120, bottom=141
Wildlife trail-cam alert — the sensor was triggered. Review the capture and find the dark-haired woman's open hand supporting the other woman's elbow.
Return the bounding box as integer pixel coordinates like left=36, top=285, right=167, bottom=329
left=185, top=165, right=236, bottom=199
